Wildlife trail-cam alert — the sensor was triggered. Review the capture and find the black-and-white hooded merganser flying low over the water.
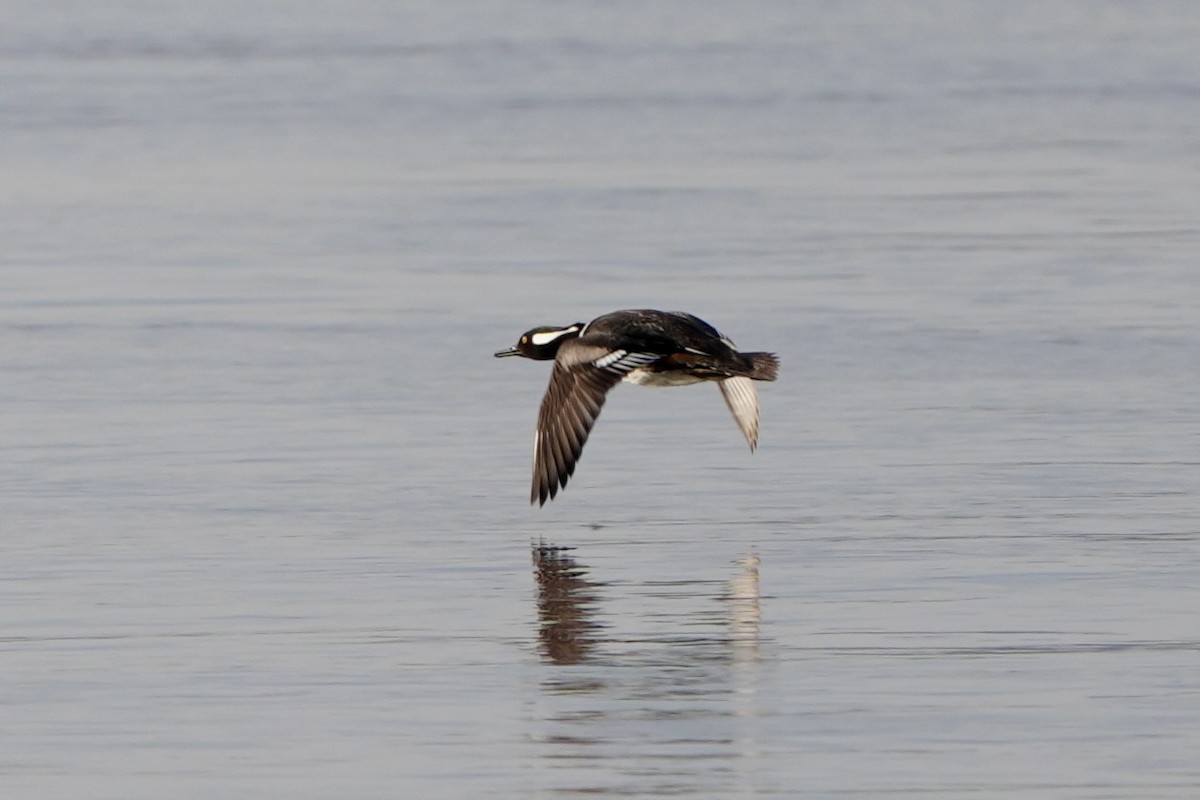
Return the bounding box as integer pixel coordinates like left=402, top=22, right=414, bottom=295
left=496, top=309, right=779, bottom=505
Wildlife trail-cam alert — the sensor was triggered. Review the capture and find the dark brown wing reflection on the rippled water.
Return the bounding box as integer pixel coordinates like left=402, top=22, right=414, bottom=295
left=533, top=542, right=600, bottom=664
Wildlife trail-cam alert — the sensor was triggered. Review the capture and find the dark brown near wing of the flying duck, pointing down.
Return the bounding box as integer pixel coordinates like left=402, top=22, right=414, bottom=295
left=529, top=339, right=660, bottom=505
